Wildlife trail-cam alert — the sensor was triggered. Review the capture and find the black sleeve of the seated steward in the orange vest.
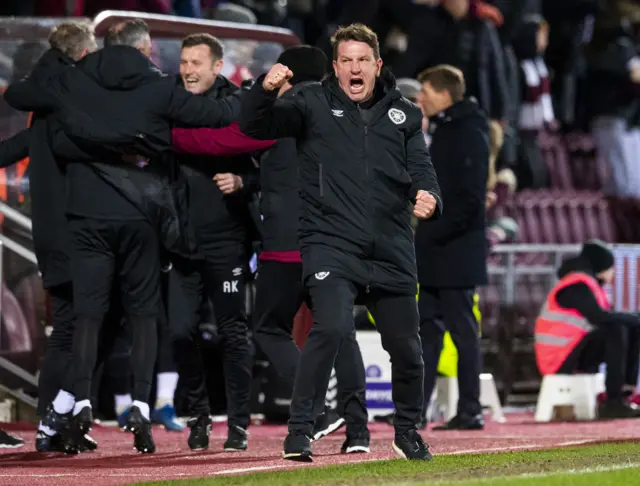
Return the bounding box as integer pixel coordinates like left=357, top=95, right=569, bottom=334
left=556, top=283, right=640, bottom=326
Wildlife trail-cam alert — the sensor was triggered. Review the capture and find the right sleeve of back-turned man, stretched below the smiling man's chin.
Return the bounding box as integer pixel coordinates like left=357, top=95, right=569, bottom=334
left=165, top=78, right=240, bottom=128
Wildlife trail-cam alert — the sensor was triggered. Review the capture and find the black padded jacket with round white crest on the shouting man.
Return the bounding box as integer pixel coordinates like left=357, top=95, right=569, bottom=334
left=240, top=71, right=442, bottom=294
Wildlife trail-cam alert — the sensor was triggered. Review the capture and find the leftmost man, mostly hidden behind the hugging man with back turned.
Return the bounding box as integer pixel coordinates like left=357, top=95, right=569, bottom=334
left=2, top=22, right=97, bottom=451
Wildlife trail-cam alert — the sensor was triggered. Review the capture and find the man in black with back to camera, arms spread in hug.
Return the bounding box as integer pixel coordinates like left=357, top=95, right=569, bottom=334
left=5, top=20, right=236, bottom=452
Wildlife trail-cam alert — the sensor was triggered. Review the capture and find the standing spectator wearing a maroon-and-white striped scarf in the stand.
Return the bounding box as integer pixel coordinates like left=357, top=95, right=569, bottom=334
left=514, top=16, right=555, bottom=189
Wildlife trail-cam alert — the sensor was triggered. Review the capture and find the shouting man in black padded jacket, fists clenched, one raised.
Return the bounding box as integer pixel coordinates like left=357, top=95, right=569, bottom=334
left=240, top=24, right=441, bottom=461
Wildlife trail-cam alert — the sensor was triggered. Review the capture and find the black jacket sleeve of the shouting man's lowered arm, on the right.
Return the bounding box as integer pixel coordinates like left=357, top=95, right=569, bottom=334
left=406, top=122, right=443, bottom=219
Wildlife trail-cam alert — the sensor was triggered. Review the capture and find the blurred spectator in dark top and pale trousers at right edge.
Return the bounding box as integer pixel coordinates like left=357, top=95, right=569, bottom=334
left=587, top=8, right=640, bottom=197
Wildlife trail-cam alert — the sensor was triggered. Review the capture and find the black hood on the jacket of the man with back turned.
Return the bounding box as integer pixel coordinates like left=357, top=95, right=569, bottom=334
left=76, top=46, right=164, bottom=91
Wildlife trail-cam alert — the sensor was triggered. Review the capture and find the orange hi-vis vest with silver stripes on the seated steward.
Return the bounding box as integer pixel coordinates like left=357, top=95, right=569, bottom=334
left=534, top=272, right=611, bottom=376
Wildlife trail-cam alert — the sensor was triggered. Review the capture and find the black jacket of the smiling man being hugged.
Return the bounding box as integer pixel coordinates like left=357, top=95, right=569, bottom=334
left=178, top=75, right=260, bottom=253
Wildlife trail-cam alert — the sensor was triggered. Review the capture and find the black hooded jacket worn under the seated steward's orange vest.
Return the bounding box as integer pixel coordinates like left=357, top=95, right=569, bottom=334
left=556, top=257, right=640, bottom=326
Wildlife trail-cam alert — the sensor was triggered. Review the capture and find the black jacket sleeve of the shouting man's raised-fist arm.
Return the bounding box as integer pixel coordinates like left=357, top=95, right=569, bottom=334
left=239, top=76, right=305, bottom=140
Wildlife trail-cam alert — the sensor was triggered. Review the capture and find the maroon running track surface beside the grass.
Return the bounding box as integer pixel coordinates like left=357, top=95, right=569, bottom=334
left=0, top=415, right=640, bottom=486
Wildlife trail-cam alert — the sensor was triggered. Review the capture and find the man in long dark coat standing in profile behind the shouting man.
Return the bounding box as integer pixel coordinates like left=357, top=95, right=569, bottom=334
left=416, top=65, right=489, bottom=429
